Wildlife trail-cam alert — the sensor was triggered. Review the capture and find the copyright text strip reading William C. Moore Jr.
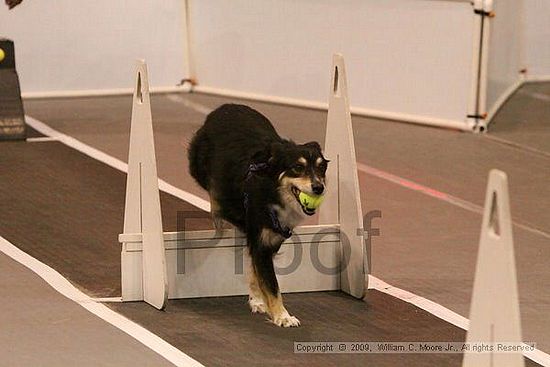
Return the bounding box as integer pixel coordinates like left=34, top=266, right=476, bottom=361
left=294, top=342, right=536, bottom=354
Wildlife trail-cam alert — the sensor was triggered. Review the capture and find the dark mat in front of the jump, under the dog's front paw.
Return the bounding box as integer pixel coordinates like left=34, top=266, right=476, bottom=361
left=110, top=290, right=536, bottom=367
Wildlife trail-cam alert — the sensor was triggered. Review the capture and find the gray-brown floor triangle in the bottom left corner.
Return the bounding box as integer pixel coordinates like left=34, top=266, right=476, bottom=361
left=0, top=253, right=176, bottom=367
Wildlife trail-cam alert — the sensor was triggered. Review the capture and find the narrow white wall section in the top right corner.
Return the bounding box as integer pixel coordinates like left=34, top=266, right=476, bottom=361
left=524, top=0, right=550, bottom=79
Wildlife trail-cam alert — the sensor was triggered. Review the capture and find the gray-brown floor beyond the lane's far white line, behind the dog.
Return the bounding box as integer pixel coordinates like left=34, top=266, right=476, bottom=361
left=16, top=84, right=550, bottom=352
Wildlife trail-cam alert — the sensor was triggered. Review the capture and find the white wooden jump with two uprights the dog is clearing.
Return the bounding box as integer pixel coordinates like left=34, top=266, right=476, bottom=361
left=119, top=54, right=368, bottom=309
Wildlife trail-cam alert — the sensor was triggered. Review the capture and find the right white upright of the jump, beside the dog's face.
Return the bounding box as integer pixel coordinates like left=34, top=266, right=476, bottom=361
left=320, top=54, right=368, bottom=298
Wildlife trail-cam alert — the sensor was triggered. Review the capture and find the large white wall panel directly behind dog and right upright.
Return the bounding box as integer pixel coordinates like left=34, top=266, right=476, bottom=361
left=191, top=0, right=474, bottom=127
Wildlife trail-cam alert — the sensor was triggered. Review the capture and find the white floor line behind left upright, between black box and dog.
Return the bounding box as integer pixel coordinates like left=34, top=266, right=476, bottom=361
left=25, top=116, right=210, bottom=212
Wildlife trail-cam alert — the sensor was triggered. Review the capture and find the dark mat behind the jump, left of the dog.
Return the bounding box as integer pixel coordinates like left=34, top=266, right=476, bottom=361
left=0, top=142, right=211, bottom=297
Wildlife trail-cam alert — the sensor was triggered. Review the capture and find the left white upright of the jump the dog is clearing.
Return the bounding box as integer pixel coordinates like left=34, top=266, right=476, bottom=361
left=122, top=60, right=168, bottom=309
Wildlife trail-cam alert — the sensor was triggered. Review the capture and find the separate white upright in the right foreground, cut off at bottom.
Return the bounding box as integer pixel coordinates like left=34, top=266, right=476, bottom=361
left=462, top=170, right=524, bottom=367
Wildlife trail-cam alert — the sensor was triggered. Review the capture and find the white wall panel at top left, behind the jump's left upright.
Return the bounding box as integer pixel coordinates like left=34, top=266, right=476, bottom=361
left=0, top=0, right=188, bottom=92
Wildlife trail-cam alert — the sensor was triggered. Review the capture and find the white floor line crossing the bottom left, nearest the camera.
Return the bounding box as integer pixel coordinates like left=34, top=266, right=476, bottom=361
left=0, top=236, right=203, bottom=367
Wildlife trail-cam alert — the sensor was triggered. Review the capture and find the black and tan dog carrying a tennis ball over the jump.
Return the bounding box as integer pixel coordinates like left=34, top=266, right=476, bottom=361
left=189, top=104, right=328, bottom=327
